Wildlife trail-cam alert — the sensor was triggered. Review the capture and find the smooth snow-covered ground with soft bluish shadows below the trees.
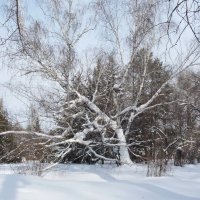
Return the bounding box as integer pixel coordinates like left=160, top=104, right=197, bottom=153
left=0, top=165, right=200, bottom=200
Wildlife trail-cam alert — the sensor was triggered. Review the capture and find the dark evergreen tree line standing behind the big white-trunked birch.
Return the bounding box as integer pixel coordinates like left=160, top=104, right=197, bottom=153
left=0, top=52, right=200, bottom=172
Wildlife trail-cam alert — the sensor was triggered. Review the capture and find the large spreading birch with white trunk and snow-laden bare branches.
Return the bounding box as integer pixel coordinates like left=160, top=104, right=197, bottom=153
left=0, top=0, right=200, bottom=164
